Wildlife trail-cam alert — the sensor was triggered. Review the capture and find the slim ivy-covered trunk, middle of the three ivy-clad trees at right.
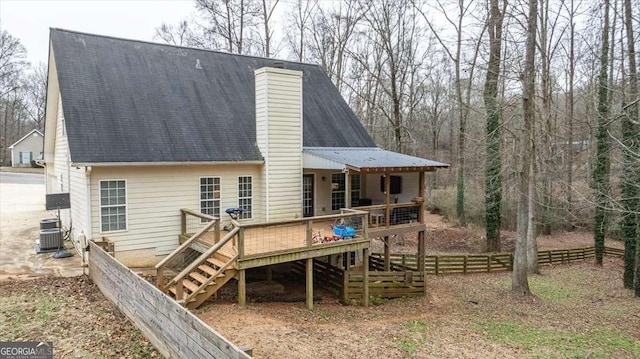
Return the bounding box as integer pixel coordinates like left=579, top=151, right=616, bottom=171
left=593, top=0, right=611, bottom=265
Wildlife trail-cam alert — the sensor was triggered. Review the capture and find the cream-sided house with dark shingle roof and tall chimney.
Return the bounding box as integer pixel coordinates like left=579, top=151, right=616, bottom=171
left=44, top=29, right=447, bottom=266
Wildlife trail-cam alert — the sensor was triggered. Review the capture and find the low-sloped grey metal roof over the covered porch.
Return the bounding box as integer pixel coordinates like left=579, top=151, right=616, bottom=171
left=302, top=147, right=449, bottom=173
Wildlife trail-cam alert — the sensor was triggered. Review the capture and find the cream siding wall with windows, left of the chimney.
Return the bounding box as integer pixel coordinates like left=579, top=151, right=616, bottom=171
left=91, top=165, right=265, bottom=255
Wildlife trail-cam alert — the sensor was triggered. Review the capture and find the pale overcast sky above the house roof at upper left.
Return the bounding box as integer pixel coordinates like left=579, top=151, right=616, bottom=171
left=0, top=0, right=194, bottom=65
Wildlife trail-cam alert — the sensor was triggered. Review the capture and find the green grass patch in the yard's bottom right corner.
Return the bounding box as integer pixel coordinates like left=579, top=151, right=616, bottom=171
left=478, top=321, right=640, bottom=358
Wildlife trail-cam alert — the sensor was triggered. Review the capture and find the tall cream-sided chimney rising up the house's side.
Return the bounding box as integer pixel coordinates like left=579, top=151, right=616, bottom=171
left=255, top=68, right=302, bottom=221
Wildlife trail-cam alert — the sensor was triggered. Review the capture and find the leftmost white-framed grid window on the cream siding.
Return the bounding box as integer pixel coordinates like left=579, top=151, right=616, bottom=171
left=100, top=180, right=127, bottom=232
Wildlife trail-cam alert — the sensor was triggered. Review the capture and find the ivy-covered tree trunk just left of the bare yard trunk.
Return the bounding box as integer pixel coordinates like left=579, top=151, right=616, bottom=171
left=483, top=0, right=503, bottom=252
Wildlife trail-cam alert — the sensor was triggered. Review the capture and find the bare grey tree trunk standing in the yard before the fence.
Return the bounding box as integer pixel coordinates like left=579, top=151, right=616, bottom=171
left=511, top=0, right=538, bottom=295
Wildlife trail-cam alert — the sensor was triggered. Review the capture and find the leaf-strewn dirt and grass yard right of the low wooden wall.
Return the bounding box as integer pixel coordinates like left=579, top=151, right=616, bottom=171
left=197, top=215, right=640, bottom=358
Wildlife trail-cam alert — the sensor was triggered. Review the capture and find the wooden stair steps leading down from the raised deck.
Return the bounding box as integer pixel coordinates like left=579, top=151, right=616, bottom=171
left=167, top=251, right=238, bottom=309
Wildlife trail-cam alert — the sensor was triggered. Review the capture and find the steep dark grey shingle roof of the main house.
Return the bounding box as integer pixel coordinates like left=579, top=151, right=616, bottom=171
left=51, top=29, right=375, bottom=163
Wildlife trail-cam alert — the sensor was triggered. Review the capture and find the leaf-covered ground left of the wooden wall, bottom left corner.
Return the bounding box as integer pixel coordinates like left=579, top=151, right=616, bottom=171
left=0, top=276, right=160, bottom=359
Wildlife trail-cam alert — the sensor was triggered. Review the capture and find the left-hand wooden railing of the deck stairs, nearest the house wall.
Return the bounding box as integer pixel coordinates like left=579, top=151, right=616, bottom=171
left=155, top=208, right=220, bottom=291
